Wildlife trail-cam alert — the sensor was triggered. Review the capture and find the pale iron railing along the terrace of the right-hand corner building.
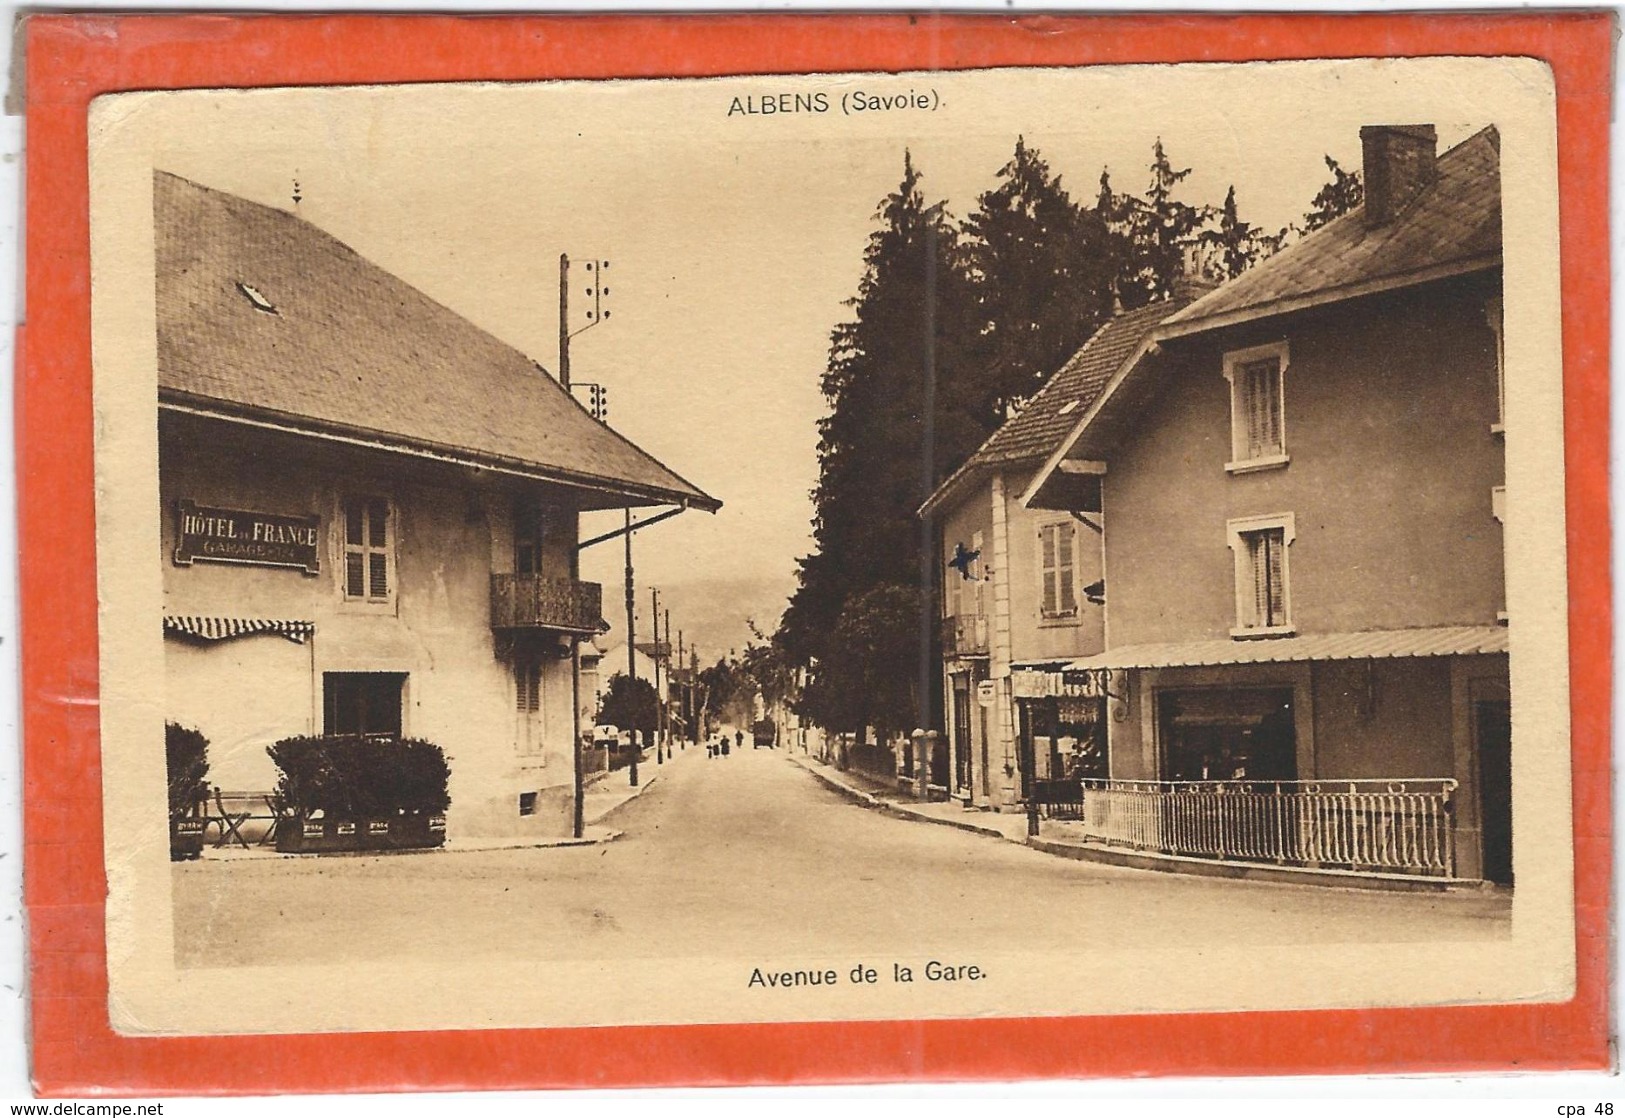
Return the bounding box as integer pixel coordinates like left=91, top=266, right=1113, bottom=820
left=1034, top=778, right=1456, bottom=878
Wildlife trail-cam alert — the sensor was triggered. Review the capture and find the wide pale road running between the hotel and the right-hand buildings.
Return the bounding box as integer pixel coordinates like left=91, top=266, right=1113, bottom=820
left=174, top=749, right=1510, bottom=965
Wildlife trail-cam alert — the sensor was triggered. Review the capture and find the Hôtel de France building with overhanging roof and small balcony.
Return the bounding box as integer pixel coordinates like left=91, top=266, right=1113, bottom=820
left=154, top=172, right=720, bottom=837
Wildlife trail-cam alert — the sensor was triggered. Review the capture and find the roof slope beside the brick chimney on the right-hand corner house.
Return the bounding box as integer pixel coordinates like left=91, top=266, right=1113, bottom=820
left=1168, top=127, right=1502, bottom=335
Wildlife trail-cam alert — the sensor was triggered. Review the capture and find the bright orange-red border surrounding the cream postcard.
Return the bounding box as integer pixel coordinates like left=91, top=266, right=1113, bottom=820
left=16, top=11, right=1615, bottom=1095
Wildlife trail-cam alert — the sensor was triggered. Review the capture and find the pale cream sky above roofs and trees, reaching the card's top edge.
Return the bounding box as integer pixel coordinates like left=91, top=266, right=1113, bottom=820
left=133, top=62, right=1489, bottom=656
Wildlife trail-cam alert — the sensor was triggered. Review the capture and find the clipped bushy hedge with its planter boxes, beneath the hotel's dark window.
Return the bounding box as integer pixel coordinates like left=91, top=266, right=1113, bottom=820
left=270, top=735, right=450, bottom=853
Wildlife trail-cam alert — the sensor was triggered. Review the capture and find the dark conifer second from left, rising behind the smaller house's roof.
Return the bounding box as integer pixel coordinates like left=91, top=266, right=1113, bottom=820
left=965, top=137, right=1113, bottom=419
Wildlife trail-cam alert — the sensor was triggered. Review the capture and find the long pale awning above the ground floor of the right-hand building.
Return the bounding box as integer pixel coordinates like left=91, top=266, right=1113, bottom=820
left=1066, top=626, right=1506, bottom=671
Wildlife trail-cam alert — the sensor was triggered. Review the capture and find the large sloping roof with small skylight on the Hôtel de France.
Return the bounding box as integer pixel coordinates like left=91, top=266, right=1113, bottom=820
left=153, top=172, right=720, bottom=509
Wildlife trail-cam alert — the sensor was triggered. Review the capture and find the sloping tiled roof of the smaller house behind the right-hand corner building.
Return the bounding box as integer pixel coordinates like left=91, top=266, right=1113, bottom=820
left=926, top=293, right=1196, bottom=507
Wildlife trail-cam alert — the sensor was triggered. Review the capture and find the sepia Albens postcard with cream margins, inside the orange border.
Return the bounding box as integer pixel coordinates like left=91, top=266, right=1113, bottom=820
left=89, top=59, right=1575, bottom=1034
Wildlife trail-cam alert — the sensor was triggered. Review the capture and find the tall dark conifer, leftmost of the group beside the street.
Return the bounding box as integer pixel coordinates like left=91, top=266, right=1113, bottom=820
left=778, top=154, right=968, bottom=735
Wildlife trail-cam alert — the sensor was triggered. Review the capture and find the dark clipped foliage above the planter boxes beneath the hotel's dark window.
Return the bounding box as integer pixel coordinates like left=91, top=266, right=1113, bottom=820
left=268, top=735, right=452, bottom=819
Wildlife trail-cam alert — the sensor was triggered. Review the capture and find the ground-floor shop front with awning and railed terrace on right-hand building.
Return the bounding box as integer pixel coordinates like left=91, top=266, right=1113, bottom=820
left=1040, top=626, right=1511, bottom=884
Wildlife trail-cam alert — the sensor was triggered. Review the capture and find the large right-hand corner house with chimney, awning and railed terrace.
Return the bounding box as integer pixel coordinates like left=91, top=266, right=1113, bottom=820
left=1022, top=125, right=1513, bottom=884
